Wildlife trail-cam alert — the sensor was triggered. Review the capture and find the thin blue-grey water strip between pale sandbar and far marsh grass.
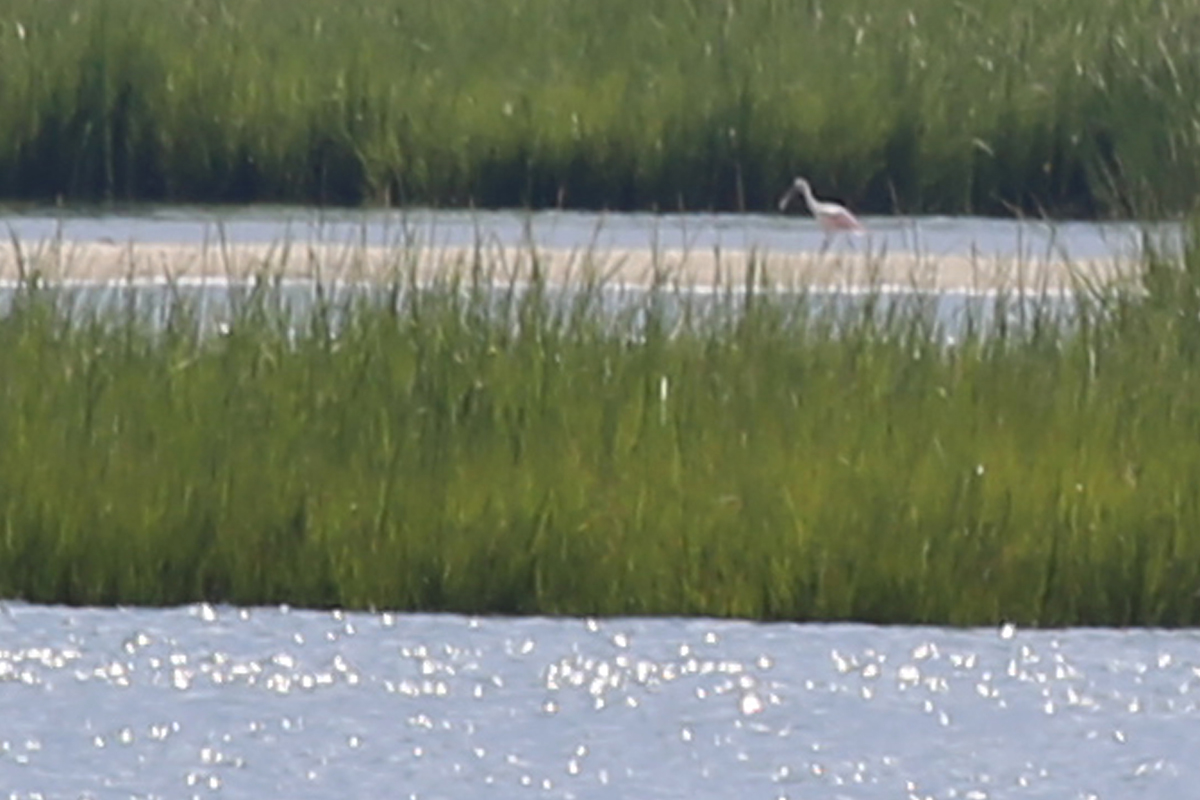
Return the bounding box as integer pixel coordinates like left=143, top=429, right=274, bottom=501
left=0, top=205, right=1178, bottom=259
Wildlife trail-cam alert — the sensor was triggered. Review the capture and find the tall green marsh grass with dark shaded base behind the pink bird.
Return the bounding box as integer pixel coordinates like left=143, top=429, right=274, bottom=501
left=0, top=0, right=1200, bottom=217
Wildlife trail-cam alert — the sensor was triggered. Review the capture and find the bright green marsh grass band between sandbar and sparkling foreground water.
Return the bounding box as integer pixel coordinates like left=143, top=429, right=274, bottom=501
left=0, top=231, right=1200, bottom=626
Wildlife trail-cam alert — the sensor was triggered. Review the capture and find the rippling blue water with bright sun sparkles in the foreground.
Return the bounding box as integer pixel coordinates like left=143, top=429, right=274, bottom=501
left=0, top=603, right=1200, bottom=800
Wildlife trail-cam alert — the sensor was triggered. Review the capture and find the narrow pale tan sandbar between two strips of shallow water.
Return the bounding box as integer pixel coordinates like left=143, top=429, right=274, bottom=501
left=0, top=240, right=1129, bottom=293
